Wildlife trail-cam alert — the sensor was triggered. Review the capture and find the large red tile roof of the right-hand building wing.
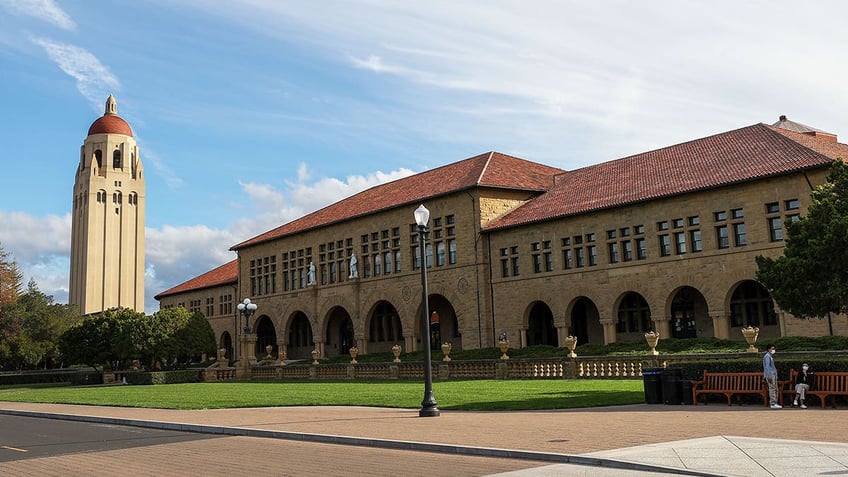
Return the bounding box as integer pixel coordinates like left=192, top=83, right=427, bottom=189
left=485, top=124, right=848, bottom=231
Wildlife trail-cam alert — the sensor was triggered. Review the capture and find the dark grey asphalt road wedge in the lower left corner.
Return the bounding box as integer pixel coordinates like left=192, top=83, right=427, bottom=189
left=0, top=415, right=221, bottom=462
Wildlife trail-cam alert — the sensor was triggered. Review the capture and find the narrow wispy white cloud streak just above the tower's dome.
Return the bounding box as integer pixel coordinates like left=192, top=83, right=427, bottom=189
left=32, top=38, right=121, bottom=107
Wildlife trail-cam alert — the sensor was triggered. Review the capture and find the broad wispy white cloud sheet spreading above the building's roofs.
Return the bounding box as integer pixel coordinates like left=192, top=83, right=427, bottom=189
left=184, top=0, right=848, bottom=168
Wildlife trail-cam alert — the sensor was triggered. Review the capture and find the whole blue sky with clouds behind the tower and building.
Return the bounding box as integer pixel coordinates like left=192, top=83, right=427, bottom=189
left=0, top=0, right=848, bottom=312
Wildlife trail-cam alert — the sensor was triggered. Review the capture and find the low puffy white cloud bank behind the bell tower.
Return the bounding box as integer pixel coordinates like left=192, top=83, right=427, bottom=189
left=0, top=166, right=413, bottom=313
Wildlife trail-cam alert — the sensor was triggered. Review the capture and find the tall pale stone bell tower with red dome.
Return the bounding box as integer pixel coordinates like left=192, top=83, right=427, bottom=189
left=68, top=95, right=144, bottom=315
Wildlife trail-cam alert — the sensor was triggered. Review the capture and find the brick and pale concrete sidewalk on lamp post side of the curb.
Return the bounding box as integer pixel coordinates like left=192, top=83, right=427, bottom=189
left=0, top=402, right=848, bottom=477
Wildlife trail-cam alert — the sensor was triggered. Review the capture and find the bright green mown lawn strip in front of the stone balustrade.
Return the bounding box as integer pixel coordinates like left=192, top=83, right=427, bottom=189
left=0, top=379, right=644, bottom=411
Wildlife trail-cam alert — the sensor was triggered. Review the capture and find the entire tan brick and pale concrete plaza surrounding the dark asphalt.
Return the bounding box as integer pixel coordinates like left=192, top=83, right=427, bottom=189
left=0, top=402, right=848, bottom=477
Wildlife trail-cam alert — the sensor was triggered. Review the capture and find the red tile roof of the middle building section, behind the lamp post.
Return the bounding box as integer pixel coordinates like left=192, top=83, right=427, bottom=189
left=230, top=152, right=564, bottom=250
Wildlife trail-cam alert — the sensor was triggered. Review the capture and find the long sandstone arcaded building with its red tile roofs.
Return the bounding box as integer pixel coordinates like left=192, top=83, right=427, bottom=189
left=156, top=118, right=848, bottom=358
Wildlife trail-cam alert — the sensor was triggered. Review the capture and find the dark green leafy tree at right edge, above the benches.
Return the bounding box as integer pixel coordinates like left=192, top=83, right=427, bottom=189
left=756, top=159, right=848, bottom=318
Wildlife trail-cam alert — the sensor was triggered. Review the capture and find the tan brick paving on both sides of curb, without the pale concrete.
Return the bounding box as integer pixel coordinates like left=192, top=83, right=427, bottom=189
left=0, top=402, right=848, bottom=475
